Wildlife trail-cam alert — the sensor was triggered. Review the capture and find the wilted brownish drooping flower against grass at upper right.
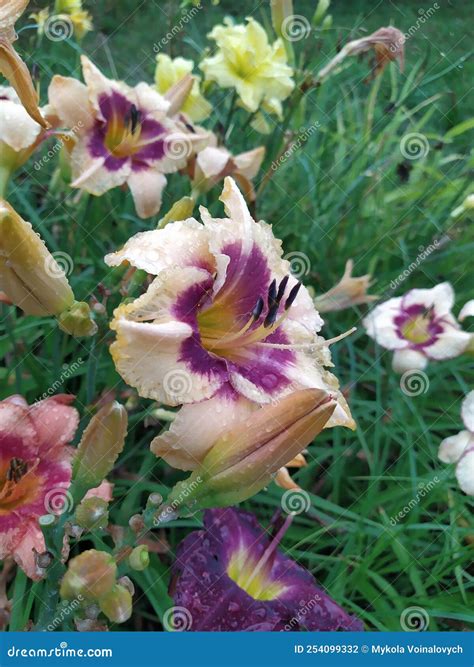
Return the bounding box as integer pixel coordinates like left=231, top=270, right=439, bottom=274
left=317, top=26, right=405, bottom=81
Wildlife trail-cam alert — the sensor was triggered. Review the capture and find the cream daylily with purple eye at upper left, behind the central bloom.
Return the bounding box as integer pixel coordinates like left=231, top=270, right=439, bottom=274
left=49, top=56, right=207, bottom=218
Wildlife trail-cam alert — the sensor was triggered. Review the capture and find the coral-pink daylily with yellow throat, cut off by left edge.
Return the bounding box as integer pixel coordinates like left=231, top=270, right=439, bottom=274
left=0, top=394, right=79, bottom=579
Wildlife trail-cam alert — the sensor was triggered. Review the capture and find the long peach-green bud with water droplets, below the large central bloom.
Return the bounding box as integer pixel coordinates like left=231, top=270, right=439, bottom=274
left=167, top=389, right=336, bottom=511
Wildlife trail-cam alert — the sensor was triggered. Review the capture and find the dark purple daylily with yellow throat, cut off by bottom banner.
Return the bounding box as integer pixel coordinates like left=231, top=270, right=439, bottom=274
left=170, top=508, right=363, bottom=632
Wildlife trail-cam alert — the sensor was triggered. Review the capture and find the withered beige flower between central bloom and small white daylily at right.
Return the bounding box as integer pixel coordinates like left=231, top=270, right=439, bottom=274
left=314, top=259, right=378, bottom=313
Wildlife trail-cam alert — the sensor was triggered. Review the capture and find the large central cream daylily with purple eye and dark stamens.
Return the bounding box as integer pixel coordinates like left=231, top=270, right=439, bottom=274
left=106, top=177, right=354, bottom=469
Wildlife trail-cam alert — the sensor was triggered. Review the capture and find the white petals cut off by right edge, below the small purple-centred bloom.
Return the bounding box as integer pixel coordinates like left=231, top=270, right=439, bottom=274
left=438, top=391, right=474, bottom=496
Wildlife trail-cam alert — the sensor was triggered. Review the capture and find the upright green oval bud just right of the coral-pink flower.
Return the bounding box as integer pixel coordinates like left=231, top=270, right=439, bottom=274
left=73, top=401, right=128, bottom=491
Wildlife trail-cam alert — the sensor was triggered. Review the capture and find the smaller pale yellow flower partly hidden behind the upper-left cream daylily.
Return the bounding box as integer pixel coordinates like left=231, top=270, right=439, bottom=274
left=155, top=53, right=212, bottom=123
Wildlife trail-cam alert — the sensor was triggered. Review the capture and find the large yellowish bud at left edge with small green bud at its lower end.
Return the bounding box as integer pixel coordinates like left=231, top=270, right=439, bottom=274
left=0, top=199, right=97, bottom=336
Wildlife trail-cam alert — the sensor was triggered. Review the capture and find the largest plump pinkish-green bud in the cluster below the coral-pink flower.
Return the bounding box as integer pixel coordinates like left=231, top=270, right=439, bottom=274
left=60, top=549, right=117, bottom=601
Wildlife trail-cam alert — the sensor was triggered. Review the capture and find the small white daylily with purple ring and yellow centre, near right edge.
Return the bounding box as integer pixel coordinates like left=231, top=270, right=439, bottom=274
left=363, top=283, right=471, bottom=373
